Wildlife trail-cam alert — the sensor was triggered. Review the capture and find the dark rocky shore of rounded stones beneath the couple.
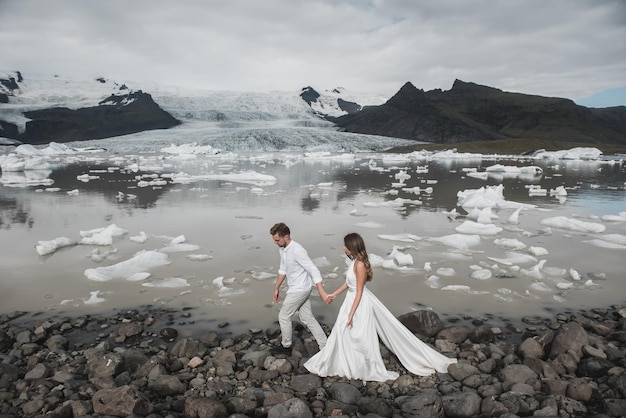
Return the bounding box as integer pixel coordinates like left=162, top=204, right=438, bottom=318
left=0, top=305, right=626, bottom=418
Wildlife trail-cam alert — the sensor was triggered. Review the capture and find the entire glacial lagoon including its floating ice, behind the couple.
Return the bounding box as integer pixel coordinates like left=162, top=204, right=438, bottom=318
left=0, top=143, right=626, bottom=331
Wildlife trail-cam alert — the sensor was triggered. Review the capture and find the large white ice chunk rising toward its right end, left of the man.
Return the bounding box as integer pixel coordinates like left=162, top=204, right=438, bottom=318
left=85, top=251, right=170, bottom=282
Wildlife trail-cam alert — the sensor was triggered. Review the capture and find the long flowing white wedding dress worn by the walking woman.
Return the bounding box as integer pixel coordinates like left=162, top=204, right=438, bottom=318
left=304, top=261, right=457, bottom=382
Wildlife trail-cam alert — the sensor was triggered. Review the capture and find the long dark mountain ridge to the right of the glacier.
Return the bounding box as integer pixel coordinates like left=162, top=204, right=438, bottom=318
left=332, top=80, right=626, bottom=144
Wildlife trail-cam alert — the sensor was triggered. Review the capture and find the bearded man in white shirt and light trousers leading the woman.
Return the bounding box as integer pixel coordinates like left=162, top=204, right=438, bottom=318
left=270, top=222, right=328, bottom=353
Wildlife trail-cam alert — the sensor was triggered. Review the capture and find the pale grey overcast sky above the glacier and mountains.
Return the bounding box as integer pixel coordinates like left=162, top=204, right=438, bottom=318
left=0, top=0, right=626, bottom=105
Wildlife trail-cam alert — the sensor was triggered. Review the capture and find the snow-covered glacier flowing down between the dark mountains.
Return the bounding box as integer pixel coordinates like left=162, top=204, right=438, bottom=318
left=0, top=71, right=407, bottom=151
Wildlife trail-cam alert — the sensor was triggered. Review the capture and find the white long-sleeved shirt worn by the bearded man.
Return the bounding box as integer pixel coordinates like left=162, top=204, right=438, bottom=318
left=278, top=240, right=322, bottom=293
